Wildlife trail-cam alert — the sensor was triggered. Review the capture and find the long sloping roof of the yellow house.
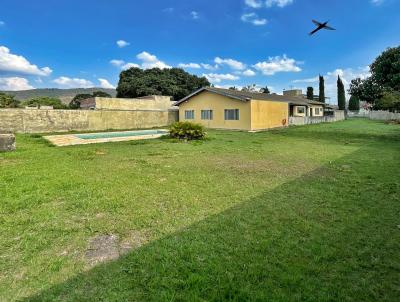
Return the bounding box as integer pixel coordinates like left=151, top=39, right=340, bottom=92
left=174, top=87, right=325, bottom=106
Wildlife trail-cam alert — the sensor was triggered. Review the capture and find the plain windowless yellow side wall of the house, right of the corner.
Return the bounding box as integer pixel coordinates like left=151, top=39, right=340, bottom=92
left=251, top=100, right=289, bottom=130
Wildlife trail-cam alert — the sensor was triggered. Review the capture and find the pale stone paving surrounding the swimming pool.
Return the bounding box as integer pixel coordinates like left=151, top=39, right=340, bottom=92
left=43, top=129, right=165, bottom=147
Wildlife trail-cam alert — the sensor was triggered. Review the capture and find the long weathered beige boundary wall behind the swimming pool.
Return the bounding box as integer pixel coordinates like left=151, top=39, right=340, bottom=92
left=0, top=109, right=176, bottom=133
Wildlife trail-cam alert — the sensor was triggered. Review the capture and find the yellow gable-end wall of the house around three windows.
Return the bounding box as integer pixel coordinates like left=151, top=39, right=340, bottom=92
left=179, top=91, right=251, bottom=130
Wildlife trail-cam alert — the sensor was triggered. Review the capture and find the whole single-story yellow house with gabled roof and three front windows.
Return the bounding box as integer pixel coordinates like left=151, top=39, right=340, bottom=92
left=174, top=87, right=324, bottom=130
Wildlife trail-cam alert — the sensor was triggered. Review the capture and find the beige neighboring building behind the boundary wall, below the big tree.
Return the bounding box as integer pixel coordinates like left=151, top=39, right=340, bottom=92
left=80, top=95, right=173, bottom=110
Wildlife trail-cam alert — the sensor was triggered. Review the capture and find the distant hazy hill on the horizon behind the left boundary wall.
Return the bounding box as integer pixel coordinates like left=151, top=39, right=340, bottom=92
left=0, top=88, right=117, bottom=104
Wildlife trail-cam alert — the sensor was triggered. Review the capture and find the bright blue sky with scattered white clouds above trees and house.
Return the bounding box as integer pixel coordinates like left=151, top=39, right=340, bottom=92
left=0, top=0, right=400, bottom=101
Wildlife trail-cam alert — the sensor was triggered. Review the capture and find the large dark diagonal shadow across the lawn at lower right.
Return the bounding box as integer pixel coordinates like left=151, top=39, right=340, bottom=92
left=26, top=140, right=400, bottom=301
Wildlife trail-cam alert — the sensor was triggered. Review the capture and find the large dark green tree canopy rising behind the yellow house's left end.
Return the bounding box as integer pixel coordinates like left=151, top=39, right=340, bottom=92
left=117, top=67, right=210, bottom=100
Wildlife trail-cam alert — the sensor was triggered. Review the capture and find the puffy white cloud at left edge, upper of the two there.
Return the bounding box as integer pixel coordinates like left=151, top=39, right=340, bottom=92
left=0, top=46, right=52, bottom=76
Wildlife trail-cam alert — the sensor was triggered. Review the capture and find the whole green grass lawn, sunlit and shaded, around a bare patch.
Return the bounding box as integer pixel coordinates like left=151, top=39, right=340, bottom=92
left=0, top=119, right=400, bottom=301
